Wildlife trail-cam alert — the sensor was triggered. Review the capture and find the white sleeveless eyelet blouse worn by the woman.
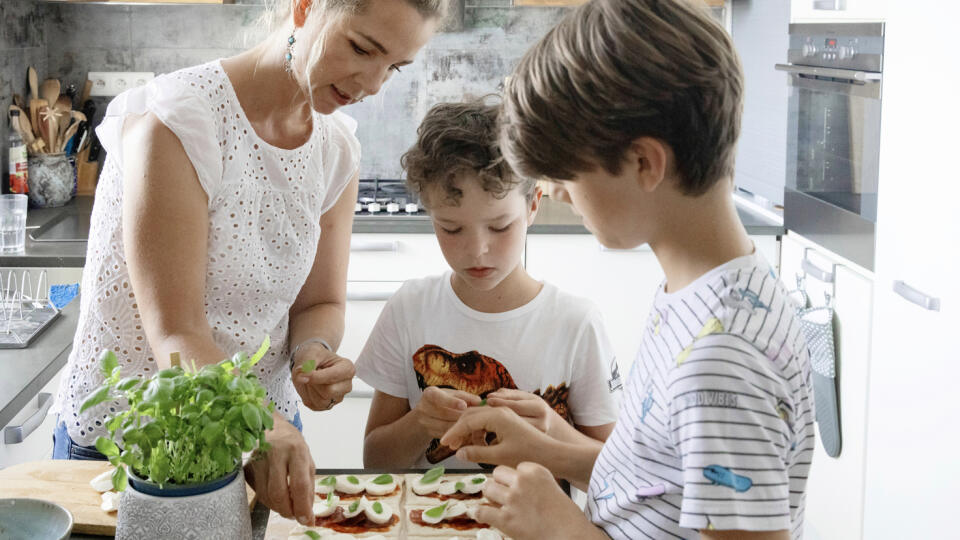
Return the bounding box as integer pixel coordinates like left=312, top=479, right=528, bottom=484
left=53, top=60, right=360, bottom=446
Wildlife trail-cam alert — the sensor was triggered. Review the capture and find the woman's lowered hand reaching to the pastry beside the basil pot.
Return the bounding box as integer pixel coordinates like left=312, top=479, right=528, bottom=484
left=244, top=413, right=315, bottom=525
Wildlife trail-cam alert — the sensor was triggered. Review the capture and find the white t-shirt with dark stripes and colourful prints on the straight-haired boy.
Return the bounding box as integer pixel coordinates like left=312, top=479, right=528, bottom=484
left=587, top=254, right=814, bottom=539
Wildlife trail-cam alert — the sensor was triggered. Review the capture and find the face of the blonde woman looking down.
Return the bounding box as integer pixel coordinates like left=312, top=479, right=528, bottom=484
left=294, top=0, right=439, bottom=114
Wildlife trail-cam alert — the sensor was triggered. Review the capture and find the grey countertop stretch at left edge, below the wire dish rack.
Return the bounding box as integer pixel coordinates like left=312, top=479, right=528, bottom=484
left=0, top=298, right=80, bottom=426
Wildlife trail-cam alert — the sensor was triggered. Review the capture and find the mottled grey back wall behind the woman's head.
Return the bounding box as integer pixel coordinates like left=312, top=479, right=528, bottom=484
left=43, top=0, right=566, bottom=178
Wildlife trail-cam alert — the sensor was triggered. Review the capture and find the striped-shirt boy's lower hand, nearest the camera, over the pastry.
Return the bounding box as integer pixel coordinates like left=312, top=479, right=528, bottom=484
left=477, top=462, right=603, bottom=540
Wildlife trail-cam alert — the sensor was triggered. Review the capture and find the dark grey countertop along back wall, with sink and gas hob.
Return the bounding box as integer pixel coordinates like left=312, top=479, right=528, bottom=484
left=0, top=197, right=785, bottom=268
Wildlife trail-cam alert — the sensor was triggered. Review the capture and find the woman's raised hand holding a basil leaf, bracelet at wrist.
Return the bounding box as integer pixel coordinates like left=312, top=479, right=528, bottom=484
left=291, top=343, right=356, bottom=411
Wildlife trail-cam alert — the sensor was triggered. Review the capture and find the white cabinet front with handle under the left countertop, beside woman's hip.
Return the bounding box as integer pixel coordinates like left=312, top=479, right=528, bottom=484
left=0, top=369, right=63, bottom=469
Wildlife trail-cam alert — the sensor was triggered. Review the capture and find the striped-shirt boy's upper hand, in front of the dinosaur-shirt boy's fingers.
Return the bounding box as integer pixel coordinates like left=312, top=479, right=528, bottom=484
left=440, top=408, right=551, bottom=466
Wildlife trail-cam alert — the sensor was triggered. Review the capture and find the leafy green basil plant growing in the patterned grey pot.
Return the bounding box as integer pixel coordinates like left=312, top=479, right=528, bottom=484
left=80, top=337, right=274, bottom=491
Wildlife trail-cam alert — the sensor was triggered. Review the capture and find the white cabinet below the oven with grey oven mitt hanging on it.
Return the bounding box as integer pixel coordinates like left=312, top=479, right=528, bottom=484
left=780, top=233, right=873, bottom=540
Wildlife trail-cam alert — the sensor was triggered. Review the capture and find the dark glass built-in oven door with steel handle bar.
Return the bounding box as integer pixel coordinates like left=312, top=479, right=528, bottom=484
left=776, top=64, right=881, bottom=268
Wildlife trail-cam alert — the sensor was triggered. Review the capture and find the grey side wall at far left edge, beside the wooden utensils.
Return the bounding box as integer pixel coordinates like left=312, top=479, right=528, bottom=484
left=0, top=0, right=47, bottom=192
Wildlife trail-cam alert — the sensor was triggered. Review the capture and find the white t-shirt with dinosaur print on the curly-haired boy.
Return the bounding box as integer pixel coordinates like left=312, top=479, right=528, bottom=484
left=357, top=272, right=620, bottom=468
